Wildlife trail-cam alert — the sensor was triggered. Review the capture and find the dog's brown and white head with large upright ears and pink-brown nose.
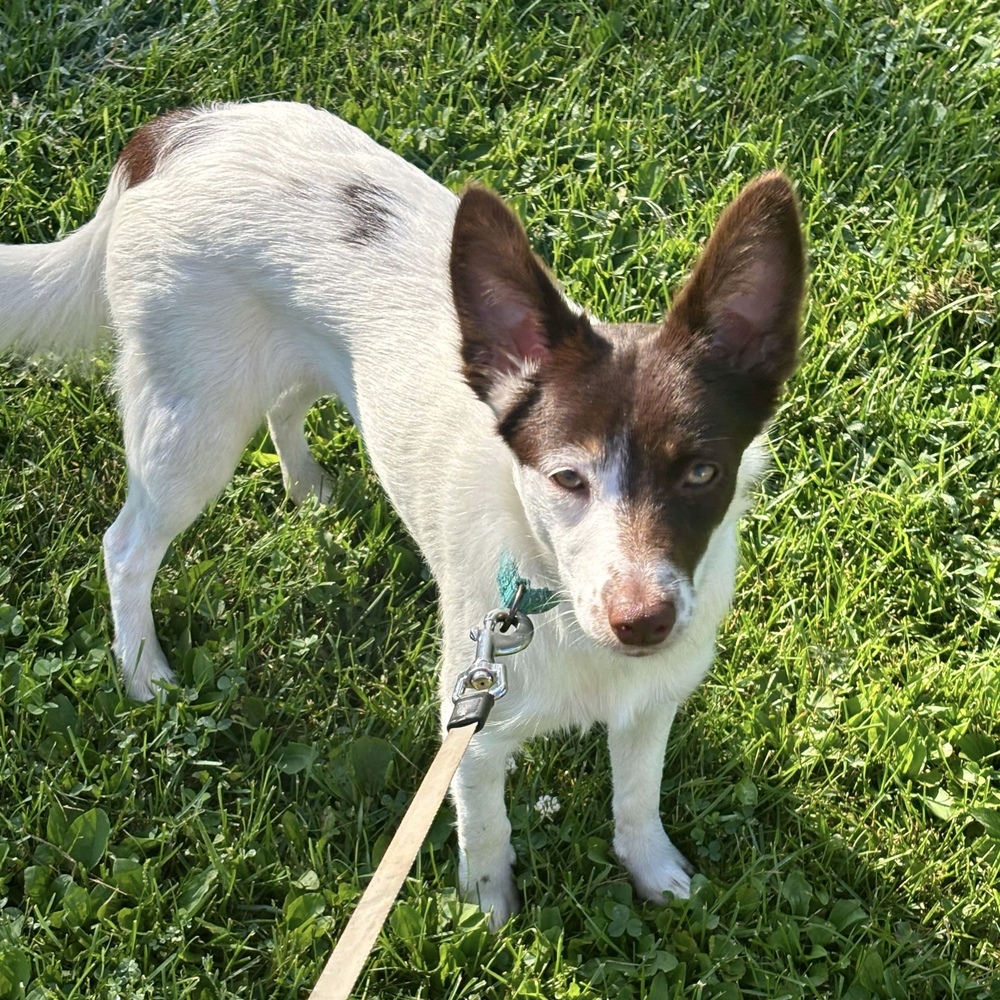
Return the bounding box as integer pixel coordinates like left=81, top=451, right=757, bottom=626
left=451, top=174, right=805, bottom=655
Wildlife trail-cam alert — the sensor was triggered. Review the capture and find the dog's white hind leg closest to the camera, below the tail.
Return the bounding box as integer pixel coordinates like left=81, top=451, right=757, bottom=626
left=104, top=355, right=260, bottom=700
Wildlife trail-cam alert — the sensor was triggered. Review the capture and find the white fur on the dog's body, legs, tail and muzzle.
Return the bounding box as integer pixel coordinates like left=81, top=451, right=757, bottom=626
left=0, top=103, right=760, bottom=927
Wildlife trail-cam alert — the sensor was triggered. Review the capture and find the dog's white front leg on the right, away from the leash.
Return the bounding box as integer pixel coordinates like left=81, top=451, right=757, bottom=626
left=608, top=702, right=692, bottom=903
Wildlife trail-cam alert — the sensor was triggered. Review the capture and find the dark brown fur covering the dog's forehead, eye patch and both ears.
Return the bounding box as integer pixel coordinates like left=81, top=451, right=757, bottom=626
left=451, top=174, right=805, bottom=576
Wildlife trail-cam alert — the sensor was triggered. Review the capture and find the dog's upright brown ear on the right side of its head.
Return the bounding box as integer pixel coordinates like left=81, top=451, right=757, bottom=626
left=664, top=173, right=805, bottom=394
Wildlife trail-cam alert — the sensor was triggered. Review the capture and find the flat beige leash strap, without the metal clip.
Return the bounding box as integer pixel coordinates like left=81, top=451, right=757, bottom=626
left=310, top=720, right=478, bottom=1000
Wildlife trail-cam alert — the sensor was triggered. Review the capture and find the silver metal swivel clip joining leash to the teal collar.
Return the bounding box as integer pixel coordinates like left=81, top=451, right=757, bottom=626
left=448, top=594, right=535, bottom=733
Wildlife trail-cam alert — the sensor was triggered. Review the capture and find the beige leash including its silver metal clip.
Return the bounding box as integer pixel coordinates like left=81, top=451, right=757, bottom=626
left=309, top=587, right=534, bottom=1000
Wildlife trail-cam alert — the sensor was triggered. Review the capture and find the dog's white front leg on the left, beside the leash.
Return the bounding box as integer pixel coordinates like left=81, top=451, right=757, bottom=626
left=451, top=727, right=521, bottom=931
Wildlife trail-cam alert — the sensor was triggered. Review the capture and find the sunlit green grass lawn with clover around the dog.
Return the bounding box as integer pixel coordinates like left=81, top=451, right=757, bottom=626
left=0, top=0, right=1000, bottom=1000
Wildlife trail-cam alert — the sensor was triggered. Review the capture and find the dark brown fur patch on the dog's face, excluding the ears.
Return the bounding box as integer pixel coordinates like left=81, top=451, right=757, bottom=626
left=508, top=316, right=767, bottom=576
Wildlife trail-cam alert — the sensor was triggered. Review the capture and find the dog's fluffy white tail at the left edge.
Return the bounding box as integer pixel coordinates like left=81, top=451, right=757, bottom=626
left=0, top=171, right=124, bottom=356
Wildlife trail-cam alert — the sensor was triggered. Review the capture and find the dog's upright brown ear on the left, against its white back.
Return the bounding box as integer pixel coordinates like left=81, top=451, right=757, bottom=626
left=451, top=187, right=580, bottom=402
